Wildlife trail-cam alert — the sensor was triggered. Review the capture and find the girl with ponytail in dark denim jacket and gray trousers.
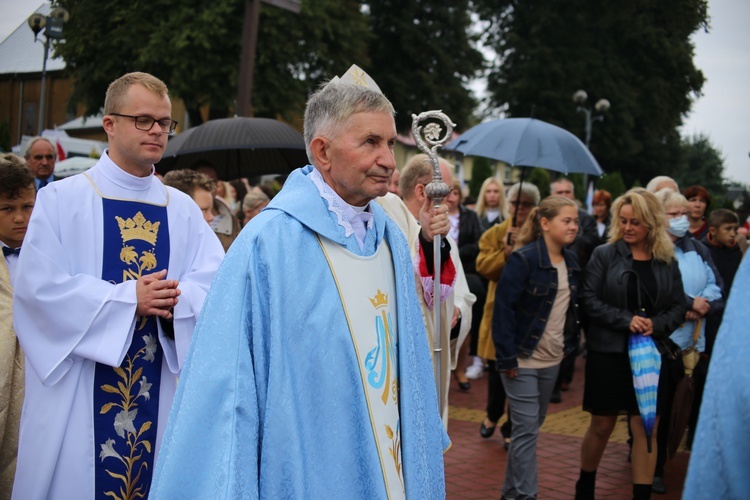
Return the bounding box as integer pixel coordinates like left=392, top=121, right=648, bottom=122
left=492, top=196, right=580, bottom=499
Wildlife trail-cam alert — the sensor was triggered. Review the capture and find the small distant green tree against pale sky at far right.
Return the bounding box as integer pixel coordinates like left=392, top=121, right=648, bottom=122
left=674, top=134, right=727, bottom=195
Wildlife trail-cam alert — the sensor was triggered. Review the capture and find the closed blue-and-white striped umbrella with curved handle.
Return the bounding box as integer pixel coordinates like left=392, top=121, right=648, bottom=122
left=619, top=269, right=661, bottom=453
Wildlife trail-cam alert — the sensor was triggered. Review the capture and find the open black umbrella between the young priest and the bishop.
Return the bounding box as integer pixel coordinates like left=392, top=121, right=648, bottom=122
left=156, top=117, right=308, bottom=180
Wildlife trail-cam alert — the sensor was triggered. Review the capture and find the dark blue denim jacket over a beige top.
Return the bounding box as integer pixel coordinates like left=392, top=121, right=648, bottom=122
left=492, top=238, right=581, bottom=370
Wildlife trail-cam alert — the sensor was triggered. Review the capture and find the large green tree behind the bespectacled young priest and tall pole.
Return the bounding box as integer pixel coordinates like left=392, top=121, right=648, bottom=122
left=57, top=0, right=368, bottom=124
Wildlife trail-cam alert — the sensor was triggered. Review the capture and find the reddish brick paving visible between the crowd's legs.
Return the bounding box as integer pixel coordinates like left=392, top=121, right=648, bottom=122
left=445, top=359, right=690, bottom=500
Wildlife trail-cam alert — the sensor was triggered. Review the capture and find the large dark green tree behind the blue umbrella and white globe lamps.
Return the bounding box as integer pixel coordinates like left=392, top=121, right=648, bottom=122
left=474, top=0, right=707, bottom=185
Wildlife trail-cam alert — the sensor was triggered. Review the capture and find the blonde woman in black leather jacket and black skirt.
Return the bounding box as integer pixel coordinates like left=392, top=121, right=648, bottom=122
left=576, top=188, right=686, bottom=499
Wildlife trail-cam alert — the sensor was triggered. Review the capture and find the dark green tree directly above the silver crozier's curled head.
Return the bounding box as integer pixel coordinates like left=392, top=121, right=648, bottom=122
left=366, top=0, right=483, bottom=132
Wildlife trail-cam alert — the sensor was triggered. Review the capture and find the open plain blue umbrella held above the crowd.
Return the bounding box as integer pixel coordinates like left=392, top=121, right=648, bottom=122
left=445, top=118, right=603, bottom=176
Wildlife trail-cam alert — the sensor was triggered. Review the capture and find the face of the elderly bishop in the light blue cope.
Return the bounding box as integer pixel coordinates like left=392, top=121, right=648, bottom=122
left=321, top=112, right=396, bottom=207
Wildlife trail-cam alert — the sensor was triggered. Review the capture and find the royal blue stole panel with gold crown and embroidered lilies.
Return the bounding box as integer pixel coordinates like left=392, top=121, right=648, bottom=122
left=94, top=198, right=169, bottom=499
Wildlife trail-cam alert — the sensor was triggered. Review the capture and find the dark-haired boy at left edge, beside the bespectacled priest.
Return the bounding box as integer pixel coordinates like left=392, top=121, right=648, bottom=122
left=0, top=154, right=36, bottom=500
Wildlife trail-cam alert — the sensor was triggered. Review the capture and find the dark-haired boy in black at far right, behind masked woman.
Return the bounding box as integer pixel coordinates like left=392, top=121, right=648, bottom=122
left=701, top=208, right=743, bottom=355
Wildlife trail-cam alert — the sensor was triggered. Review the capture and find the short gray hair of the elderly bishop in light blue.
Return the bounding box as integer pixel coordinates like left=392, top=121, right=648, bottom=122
left=304, top=80, right=396, bottom=165
